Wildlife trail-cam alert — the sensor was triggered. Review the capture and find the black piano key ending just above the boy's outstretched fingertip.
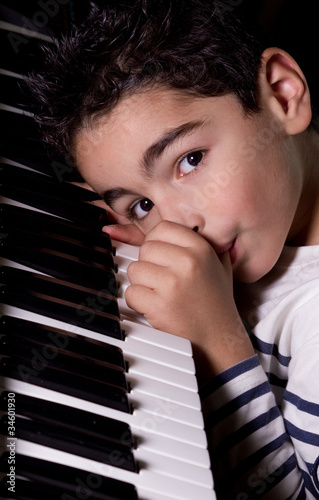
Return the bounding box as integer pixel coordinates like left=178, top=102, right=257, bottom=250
left=0, top=165, right=108, bottom=228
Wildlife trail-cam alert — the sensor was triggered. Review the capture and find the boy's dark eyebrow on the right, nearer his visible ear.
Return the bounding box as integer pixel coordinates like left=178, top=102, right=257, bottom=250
left=142, top=120, right=207, bottom=178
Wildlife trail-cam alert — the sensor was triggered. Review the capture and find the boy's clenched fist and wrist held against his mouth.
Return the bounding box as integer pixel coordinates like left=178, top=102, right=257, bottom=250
left=125, top=221, right=254, bottom=378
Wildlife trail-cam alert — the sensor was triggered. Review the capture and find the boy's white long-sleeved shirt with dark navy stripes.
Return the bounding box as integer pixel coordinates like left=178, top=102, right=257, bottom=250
left=201, top=246, right=319, bottom=500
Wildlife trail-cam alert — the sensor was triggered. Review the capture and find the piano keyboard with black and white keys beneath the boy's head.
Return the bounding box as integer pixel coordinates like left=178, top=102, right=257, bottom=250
left=0, top=2, right=216, bottom=500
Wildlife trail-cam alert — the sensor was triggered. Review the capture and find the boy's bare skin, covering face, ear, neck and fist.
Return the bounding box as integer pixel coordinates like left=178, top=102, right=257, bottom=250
left=75, top=48, right=319, bottom=382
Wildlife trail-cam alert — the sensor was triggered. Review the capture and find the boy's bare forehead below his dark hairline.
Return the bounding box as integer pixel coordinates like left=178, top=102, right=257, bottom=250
left=74, top=89, right=245, bottom=192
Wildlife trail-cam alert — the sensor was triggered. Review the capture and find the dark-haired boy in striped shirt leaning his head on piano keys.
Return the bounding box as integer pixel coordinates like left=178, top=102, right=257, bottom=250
left=26, top=0, right=319, bottom=500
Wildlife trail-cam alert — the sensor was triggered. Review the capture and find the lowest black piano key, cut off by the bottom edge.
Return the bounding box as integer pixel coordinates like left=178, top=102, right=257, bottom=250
left=0, top=453, right=138, bottom=500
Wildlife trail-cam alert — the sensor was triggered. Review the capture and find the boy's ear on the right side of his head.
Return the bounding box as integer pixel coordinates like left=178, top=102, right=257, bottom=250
left=259, top=47, right=311, bottom=135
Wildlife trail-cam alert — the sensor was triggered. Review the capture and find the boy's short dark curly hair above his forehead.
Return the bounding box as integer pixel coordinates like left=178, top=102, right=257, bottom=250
left=28, top=0, right=264, bottom=160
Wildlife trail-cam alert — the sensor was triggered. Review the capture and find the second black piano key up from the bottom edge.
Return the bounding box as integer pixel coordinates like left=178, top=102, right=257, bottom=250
left=0, top=415, right=138, bottom=472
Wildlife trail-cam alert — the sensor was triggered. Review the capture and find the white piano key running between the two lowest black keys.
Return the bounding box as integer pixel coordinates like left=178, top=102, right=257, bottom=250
left=16, top=439, right=216, bottom=500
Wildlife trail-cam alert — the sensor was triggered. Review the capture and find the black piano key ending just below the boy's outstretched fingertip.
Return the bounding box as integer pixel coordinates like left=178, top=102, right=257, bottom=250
left=0, top=203, right=114, bottom=255
